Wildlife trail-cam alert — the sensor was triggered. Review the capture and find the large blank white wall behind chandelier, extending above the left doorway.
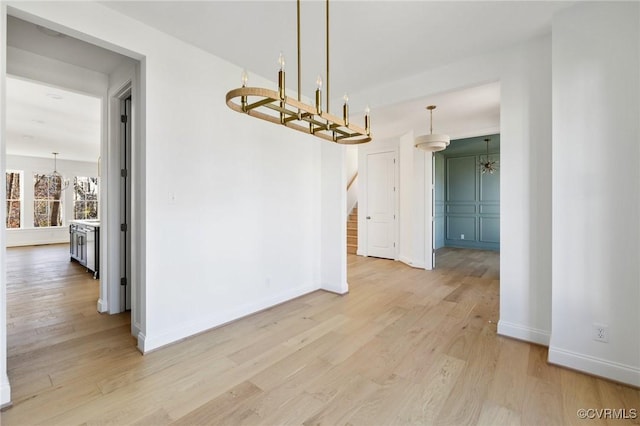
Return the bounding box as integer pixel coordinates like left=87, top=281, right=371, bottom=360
left=2, top=2, right=346, bottom=406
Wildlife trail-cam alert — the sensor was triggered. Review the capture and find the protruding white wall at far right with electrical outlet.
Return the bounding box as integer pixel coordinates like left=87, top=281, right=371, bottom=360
left=549, top=2, right=640, bottom=386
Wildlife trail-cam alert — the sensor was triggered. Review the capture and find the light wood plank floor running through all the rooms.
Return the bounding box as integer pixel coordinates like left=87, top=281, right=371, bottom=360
left=0, top=246, right=640, bottom=425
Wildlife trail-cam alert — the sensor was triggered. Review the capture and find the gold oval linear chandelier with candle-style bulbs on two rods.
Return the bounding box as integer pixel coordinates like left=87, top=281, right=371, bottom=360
left=226, top=0, right=371, bottom=144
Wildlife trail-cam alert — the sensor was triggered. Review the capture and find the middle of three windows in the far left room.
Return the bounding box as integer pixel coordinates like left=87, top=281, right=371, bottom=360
left=33, top=174, right=62, bottom=228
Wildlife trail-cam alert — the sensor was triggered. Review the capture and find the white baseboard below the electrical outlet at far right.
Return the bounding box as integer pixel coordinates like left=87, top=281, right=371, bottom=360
left=549, top=346, right=640, bottom=387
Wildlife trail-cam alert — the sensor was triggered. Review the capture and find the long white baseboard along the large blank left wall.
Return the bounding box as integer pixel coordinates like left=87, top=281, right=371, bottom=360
left=138, top=285, right=320, bottom=354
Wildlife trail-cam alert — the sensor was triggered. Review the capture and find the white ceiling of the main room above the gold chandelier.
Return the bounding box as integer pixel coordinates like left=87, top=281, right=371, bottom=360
left=103, top=0, right=573, bottom=97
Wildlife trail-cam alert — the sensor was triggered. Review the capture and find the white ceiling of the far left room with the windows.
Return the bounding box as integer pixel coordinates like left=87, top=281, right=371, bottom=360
left=6, top=76, right=101, bottom=161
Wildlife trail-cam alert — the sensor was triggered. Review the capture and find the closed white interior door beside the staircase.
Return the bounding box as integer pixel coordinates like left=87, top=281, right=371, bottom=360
left=366, top=151, right=396, bottom=259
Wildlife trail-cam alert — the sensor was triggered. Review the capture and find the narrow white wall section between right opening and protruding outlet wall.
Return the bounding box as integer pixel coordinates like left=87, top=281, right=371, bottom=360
left=498, top=37, right=551, bottom=345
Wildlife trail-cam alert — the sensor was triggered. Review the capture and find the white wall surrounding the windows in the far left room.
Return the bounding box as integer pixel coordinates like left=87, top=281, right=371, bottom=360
left=6, top=155, right=98, bottom=247
